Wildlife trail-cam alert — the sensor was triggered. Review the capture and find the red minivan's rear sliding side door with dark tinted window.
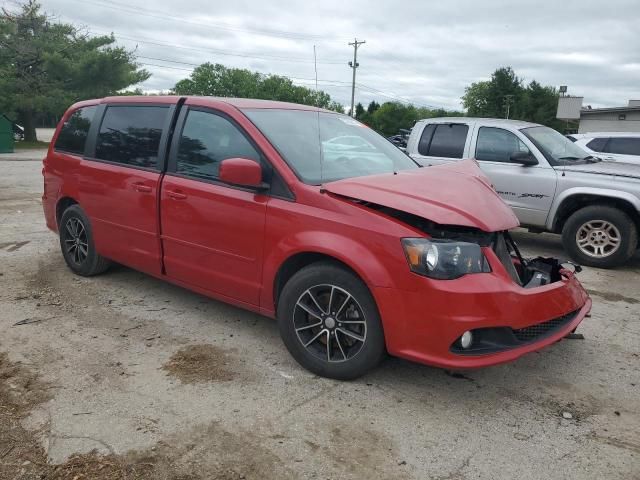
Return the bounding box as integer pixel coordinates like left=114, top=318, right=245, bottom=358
left=77, top=104, right=173, bottom=275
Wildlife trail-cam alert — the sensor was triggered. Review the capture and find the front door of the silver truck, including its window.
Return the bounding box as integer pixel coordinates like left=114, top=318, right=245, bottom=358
left=471, top=126, right=557, bottom=226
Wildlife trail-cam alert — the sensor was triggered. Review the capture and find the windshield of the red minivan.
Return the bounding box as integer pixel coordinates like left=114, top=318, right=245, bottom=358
left=244, top=109, right=419, bottom=185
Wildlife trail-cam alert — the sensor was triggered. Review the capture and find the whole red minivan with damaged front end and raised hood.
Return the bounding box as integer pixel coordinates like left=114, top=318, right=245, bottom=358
left=42, top=96, right=591, bottom=379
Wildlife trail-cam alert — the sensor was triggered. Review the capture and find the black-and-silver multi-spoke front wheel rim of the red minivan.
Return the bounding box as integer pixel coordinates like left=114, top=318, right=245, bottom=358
left=293, top=284, right=367, bottom=362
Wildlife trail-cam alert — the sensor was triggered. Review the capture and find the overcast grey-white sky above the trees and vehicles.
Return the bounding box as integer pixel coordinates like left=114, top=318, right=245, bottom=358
left=37, top=0, right=640, bottom=109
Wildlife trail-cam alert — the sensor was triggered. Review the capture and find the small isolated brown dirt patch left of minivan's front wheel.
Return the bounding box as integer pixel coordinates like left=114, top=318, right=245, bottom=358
left=162, top=345, right=235, bottom=383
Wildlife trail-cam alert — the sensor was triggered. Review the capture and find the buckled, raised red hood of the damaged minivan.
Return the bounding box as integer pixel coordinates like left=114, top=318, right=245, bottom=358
left=323, top=160, right=519, bottom=232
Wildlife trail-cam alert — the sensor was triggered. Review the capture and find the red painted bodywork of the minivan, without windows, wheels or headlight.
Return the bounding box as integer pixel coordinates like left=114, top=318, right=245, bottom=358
left=43, top=97, right=591, bottom=368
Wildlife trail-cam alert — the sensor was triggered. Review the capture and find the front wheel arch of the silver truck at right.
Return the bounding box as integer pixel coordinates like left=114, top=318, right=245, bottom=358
left=547, top=189, right=640, bottom=233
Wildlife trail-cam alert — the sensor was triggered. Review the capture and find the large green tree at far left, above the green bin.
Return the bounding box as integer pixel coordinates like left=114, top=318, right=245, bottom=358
left=0, top=0, right=150, bottom=141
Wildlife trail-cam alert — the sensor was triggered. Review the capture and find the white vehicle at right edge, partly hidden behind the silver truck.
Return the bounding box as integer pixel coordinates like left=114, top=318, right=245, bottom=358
left=567, top=132, right=640, bottom=164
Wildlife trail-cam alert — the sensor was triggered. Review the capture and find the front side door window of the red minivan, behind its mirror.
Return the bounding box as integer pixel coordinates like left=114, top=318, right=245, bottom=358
left=176, top=110, right=260, bottom=180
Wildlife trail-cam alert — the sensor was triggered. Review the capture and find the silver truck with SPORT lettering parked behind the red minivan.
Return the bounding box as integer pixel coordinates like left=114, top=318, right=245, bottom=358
left=406, top=117, right=640, bottom=268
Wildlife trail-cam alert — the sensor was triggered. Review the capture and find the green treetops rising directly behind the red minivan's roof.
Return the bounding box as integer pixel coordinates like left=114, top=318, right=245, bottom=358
left=173, top=63, right=344, bottom=112
